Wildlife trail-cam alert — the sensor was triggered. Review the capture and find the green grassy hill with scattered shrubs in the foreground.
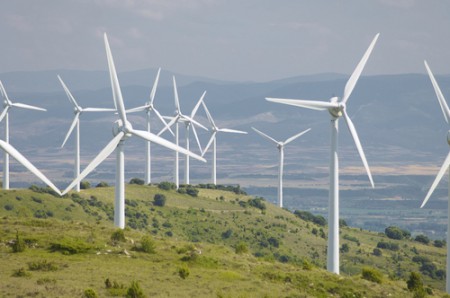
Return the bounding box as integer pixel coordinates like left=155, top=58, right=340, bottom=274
left=0, top=184, right=446, bottom=297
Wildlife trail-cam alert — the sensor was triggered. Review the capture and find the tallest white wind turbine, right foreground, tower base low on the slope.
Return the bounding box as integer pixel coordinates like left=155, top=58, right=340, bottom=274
left=266, top=33, right=380, bottom=274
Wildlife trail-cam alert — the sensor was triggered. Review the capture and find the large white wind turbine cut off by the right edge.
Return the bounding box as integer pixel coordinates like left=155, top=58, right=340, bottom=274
left=420, top=61, right=450, bottom=293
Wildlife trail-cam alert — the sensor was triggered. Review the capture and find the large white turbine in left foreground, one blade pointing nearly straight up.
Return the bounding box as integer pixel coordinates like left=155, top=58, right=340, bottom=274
left=63, top=33, right=206, bottom=229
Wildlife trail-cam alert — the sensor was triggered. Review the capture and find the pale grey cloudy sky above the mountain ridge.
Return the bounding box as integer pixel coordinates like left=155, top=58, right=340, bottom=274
left=0, top=0, right=450, bottom=81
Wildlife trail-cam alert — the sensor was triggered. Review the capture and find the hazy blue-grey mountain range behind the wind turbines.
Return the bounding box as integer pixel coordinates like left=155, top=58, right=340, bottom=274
left=0, top=69, right=450, bottom=187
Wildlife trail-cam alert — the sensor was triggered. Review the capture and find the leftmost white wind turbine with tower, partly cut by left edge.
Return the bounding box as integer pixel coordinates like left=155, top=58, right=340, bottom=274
left=0, top=81, right=47, bottom=189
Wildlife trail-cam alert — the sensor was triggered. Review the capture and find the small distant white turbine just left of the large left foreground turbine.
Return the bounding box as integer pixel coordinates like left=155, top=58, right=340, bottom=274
left=58, top=76, right=116, bottom=192
